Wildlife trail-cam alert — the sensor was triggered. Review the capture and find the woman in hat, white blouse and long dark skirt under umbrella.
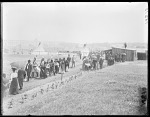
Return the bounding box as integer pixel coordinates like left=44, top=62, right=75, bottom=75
left=9, top=67, right=19, bottom=95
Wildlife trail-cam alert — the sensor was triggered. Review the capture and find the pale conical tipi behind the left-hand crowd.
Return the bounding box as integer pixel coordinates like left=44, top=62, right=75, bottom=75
left=32, top=42, right=48, bottom=55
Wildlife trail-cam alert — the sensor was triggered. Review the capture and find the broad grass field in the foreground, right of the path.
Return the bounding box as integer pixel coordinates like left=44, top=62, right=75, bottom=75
left=4, top=61, right=147, bottom=115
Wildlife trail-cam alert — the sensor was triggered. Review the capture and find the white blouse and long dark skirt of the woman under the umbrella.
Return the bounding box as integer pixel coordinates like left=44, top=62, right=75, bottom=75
left=9, top=73, right=18, bottom=95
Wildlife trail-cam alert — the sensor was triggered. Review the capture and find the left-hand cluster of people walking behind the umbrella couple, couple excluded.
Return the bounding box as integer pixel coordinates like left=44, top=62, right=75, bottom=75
left=25, top=55, right=75, bottom=81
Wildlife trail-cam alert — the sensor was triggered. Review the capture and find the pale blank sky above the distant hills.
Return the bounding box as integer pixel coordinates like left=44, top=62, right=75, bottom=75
left=2, top=2, right=148, bottom=43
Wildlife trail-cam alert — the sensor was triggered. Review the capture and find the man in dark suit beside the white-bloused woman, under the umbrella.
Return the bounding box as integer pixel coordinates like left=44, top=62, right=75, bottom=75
left=18, top=68, right=26, bottom=90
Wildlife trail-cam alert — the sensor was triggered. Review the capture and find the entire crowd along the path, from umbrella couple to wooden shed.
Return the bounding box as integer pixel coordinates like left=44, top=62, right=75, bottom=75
left=3, top=53, right=125, bottom=94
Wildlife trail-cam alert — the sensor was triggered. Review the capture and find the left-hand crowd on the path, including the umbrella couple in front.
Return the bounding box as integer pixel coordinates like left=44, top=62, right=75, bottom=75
left=3, top=55, right=75, bottom=95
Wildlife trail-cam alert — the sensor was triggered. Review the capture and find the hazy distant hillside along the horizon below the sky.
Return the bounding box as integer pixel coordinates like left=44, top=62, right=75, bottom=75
left=3, top=40, right=148, bottom=52
